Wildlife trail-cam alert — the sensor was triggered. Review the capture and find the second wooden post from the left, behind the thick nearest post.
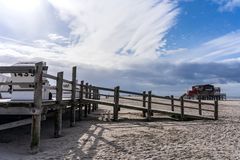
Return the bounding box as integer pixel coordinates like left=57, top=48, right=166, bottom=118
left=54, top=72, right=63, bottom=138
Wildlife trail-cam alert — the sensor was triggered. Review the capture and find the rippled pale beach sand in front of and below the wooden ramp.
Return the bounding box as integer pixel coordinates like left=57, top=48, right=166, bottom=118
left=0, top=101, right=240, bottom=160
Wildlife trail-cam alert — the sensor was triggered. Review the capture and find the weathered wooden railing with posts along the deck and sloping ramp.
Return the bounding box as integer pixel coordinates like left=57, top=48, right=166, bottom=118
left=0, top=62, right=218, bottom=152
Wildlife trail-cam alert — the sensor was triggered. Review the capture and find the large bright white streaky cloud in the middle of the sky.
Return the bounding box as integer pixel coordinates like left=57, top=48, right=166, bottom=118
left=49, top=0, right=179, bottom=68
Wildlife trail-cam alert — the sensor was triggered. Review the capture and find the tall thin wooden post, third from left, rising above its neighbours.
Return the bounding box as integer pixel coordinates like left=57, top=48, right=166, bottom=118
left=70, top=66, right=77, bottom=127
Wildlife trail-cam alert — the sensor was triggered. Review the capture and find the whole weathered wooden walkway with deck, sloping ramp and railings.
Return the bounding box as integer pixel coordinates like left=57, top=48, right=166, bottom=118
left=0, top=63, right=218, bottom=153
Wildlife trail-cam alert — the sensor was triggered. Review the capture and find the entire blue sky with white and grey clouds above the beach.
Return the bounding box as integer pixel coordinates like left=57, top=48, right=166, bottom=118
left=0, top=0, right=240, bottom=96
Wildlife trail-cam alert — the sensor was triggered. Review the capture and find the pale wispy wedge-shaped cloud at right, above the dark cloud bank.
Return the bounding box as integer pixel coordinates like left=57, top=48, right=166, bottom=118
left=171, top=30, right=240, bottom=63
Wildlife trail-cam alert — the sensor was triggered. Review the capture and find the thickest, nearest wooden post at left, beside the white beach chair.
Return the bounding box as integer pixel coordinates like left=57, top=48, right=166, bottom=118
left=30, top=62, right=43, bottom=153
